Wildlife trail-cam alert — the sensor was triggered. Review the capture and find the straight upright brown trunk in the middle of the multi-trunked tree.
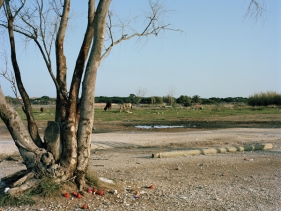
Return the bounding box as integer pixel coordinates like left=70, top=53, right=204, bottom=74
left=55, top=0, right=77, bottom=174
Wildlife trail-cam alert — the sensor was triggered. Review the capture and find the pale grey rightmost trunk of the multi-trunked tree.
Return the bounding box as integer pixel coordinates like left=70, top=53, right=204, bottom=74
left=76, top=0, right=111, bottom=190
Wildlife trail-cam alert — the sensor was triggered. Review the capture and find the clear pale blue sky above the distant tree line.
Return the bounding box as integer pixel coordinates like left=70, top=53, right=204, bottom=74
left=0, top=0, right=281, bottom=98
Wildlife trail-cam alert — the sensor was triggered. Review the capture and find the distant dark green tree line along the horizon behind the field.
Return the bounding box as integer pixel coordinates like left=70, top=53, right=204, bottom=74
left=6, top=92, right=281, bottom=106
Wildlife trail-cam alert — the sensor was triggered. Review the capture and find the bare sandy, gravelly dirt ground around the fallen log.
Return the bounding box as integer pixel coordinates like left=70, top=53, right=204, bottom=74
left=0, top=125, right=281, bottom=211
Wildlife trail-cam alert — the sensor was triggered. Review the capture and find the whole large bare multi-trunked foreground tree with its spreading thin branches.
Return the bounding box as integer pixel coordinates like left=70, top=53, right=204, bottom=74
left=0, top=0, right=173, bottom=195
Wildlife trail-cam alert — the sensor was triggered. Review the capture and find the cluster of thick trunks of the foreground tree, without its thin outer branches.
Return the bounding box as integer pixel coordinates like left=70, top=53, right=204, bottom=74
left=0, top=0, right=111, bottom=193
